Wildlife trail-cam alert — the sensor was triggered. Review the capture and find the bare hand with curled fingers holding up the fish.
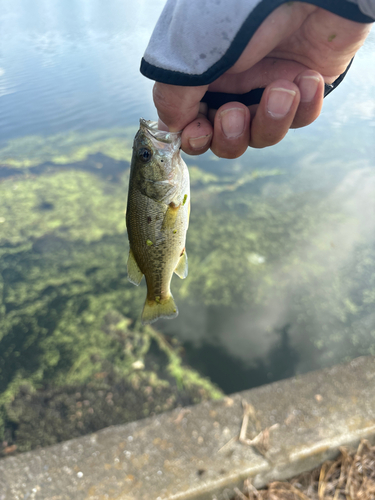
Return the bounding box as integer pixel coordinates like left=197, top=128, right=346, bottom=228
left=154, top=2, right=371, bottom=158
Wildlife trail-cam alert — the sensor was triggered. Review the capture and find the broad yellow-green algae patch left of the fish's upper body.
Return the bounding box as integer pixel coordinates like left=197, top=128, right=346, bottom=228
left=0, top=170, right=127, bottom=245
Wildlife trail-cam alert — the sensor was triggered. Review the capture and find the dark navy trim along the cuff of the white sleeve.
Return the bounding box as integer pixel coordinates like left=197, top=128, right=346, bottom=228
left=140, top=0, right=374, bottom=86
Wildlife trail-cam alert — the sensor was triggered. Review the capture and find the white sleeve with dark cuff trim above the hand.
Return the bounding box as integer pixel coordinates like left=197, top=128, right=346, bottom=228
left=141, top=0, right=375, bottom=86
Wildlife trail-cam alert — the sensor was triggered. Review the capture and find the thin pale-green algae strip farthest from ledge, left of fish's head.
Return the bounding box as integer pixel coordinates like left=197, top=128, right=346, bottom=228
left=0, top=127, right=136, bottom=169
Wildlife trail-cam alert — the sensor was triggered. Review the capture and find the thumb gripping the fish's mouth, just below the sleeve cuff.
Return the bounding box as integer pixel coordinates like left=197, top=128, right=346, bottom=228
left=153, top=82, right=208, bottom=132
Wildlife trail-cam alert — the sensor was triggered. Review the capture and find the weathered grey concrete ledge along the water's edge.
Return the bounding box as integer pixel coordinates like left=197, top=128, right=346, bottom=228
left=0, top=357, right=375, bottom=500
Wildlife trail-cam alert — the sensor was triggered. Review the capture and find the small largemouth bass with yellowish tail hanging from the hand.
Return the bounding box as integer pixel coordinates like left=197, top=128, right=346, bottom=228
left=126, top=119, right=190, bottom=323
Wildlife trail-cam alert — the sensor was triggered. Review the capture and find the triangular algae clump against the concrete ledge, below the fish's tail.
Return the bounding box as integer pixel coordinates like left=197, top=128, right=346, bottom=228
left=0, top=311, right=222, bottom=454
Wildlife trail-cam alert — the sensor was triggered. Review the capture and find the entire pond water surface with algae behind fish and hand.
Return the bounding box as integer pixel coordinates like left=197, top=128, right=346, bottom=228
left=0, top=0, right=375, bottom=449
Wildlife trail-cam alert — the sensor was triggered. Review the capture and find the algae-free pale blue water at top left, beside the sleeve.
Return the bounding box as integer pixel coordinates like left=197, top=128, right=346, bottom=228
left=0, top=0, right=164, bottom=141
